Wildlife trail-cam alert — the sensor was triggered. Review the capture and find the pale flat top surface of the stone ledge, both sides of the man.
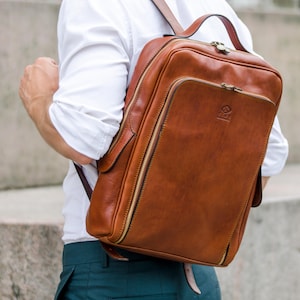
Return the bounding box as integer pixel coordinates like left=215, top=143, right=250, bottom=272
left=0, top=164, right=300, bottom=224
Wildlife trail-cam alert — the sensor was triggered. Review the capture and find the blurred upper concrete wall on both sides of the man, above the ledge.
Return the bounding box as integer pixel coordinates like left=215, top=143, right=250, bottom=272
left=0, top=0, right=300, bottom=189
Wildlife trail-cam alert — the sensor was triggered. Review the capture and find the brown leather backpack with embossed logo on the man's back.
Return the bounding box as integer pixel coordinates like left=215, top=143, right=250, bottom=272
left=87, top=7, right=282, bottom=266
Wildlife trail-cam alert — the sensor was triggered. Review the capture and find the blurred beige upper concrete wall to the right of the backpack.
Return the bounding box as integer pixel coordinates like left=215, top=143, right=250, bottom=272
left=238, top=10, right=300, bottom=163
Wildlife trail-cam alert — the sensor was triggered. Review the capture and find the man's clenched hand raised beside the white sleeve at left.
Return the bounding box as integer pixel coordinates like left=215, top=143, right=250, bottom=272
left=19, top=57, right=58, bottom=121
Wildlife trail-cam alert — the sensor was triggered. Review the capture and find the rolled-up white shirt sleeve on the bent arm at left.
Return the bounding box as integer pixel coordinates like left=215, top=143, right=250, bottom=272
left=49, top=1, right=130, bottom=159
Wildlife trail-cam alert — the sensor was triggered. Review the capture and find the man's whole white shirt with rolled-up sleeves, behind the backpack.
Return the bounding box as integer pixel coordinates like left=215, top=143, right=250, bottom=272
left=50, top=0, right=288, bottom=243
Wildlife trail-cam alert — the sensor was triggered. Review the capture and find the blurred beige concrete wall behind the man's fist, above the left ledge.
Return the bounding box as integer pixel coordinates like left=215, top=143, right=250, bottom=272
left=0, top=1, right=66, bottom=189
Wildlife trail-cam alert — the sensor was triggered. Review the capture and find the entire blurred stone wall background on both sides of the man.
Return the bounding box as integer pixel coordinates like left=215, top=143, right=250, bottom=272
left=0, top=0, right=300, bottom=300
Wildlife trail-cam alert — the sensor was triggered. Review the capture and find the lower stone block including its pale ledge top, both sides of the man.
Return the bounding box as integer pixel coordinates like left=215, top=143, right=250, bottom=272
left=0, top=166, right=300, bottom=300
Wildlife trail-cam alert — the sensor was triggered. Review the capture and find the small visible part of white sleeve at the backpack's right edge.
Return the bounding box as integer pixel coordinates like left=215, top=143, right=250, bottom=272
left=262, top=117, right=289, bottom=176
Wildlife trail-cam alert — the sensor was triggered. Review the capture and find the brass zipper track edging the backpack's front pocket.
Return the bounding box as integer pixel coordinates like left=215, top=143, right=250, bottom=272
left=115, top=77, right=276, bottom=244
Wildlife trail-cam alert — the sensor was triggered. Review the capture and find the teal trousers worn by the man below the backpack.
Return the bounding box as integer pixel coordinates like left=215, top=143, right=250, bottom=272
left=55, top=241, right=221, bottom=300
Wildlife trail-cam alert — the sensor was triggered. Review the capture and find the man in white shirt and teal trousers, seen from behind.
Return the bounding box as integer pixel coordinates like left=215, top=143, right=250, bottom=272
left=20, top=0, right=288, bottom=300
